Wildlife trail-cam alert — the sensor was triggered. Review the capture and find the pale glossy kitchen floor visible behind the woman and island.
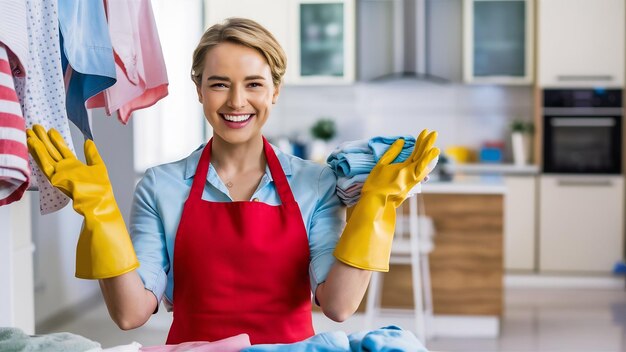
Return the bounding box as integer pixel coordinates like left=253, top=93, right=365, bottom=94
left=38, top=288, right=626, bottom=352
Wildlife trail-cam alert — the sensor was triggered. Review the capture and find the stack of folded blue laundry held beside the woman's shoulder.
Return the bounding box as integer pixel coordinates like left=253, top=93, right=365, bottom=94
left=326, top=136, right=436, bottom=207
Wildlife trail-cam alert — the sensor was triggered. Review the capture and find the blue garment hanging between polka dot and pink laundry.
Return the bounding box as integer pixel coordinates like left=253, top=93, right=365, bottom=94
left=59, top=0, right=116, bottom=139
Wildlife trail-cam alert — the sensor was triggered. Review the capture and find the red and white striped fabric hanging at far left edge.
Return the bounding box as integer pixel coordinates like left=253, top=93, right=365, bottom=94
left=0, top=43, right=30, bottom=206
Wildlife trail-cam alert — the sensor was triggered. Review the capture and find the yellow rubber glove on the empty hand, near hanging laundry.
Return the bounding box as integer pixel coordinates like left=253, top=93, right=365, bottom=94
left=26, top=125, right=139, bottom=279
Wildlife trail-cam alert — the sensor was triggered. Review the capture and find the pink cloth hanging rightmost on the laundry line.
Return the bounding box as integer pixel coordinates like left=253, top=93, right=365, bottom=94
left=87, top=0, right=168, bottom=124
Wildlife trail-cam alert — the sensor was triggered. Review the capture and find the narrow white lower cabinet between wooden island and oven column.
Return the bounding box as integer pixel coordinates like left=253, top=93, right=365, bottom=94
left=504, top=175, right=537, bottom=271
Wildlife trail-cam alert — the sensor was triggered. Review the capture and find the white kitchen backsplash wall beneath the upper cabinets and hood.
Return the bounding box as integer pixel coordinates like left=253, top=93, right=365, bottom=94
left=265, top=80, right=533, bottom=160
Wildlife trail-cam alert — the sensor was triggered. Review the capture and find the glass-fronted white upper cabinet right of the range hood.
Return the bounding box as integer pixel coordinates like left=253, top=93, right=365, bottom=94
left=463, top=0, right=534, bottom=84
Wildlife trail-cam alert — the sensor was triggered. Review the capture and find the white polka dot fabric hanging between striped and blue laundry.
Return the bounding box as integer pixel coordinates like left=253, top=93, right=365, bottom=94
left=15, top=0, right=74, bottom=214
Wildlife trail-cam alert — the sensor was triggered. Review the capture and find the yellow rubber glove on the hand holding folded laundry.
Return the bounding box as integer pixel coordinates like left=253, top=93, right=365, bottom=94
left=334, top=130, right=439, bottom=272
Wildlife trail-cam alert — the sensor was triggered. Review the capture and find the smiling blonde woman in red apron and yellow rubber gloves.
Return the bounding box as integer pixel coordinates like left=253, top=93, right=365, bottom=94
left=28, top=18, right=438, bottom=344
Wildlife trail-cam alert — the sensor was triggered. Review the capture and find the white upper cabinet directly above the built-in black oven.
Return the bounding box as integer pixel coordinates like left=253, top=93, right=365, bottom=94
left=537, top=0, right=626, bottom=87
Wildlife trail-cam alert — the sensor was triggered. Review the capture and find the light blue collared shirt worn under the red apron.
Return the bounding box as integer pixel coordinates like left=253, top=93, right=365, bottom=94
left=130, top=146, right=345, bottom=306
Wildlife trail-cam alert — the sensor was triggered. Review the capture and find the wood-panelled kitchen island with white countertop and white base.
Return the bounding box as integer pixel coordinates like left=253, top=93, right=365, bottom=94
left=358, top=175, right=506, bottom=337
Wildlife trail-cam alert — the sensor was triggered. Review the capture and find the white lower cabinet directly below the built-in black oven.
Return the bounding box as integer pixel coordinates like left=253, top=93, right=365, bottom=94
left=539, top=175, right=624, bottom=274
